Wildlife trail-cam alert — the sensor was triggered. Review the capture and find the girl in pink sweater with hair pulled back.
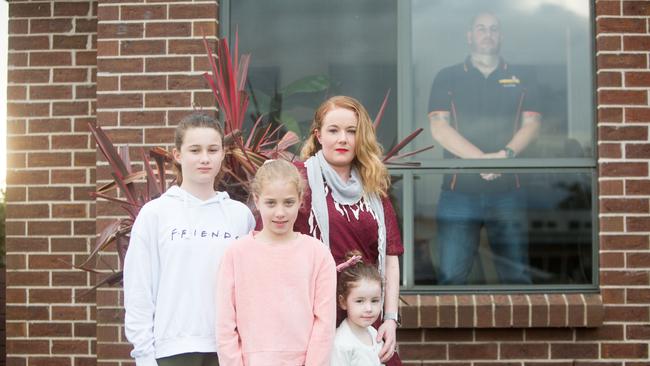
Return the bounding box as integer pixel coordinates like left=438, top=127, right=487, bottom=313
left=216, top=160, right=336, bottom=366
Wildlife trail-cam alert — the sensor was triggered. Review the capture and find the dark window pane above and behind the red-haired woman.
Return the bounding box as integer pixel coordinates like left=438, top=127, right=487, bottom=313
left=230, top=0, right=397, bottom=148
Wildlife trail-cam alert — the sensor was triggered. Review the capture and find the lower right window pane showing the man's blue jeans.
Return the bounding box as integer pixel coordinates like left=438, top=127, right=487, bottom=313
left=407, top=172, right=593, bottom=286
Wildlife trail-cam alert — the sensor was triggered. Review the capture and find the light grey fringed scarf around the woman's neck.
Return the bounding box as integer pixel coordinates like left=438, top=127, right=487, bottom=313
left=305, top=150, right=386, bottom=307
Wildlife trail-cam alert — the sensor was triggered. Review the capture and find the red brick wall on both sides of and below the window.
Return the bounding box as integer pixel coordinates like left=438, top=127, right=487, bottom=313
left=7, top=0, right=650, bottom=366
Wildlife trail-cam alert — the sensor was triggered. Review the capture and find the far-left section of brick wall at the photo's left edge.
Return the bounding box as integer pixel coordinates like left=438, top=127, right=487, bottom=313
left=6, top=0, right=96, bottom=366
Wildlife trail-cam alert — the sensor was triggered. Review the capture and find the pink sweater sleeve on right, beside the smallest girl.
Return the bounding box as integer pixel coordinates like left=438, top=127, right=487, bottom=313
left=305, top=250, right=336, bottom=366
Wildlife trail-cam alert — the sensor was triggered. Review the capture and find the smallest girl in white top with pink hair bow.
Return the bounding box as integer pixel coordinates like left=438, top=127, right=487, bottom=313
left=331, top=251, right=382, bottom=366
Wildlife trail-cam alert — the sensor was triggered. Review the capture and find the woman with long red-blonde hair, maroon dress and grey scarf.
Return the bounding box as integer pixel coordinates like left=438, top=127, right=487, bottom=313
left=294, top=96, right=404, bottom=366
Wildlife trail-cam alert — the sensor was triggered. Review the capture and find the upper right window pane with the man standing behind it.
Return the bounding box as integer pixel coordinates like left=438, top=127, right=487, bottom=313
left=409, top=0, right=595, bottom=160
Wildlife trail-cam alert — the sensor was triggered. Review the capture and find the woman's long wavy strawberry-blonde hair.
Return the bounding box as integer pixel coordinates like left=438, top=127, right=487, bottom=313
left=300, top=95, right=390, bottom=197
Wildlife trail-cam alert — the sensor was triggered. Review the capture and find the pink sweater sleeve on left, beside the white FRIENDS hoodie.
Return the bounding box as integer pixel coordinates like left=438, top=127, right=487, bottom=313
left=216, top=250, right=244, bottom=366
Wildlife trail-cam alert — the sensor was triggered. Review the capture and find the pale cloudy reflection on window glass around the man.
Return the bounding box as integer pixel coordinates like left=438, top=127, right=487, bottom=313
left=411, top=0, right=594, bottom=161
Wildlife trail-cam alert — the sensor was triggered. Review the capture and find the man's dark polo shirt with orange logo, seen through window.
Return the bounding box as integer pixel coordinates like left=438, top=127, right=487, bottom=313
left=429, top=57, right=540, bottom=191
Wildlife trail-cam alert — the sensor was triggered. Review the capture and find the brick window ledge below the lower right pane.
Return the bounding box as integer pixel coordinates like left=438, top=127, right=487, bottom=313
left=400, top=294, right=604, bottom=329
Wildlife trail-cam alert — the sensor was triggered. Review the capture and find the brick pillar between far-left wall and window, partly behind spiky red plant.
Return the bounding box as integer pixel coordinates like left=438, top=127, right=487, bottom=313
left=97, top=0, right=217, bottom=365
